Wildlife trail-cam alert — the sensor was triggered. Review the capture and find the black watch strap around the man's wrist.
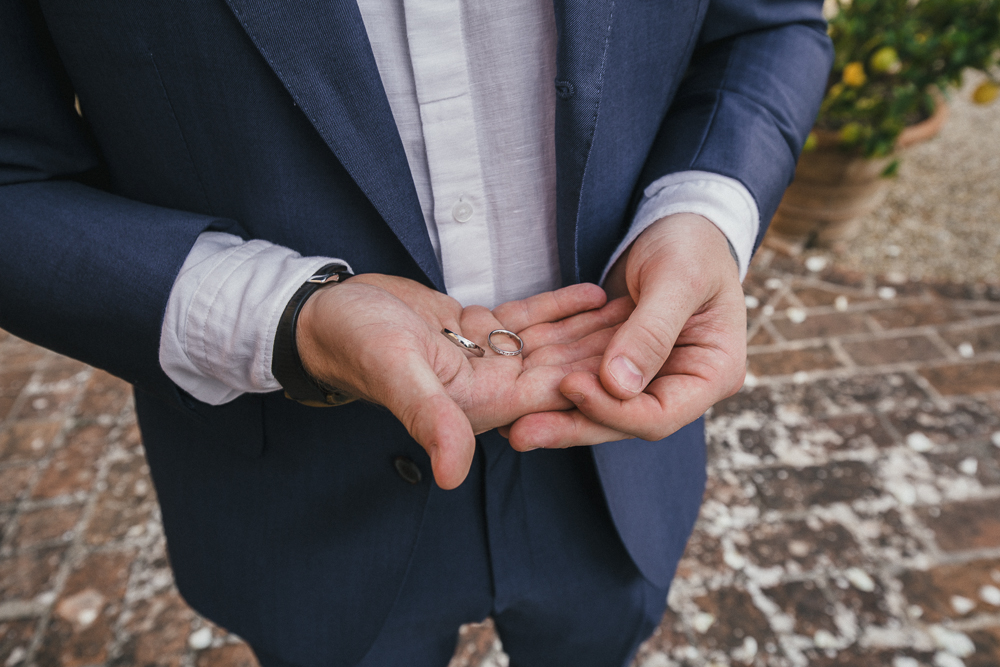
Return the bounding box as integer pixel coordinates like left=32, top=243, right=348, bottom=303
left=271, top=262, right=356, bottom=407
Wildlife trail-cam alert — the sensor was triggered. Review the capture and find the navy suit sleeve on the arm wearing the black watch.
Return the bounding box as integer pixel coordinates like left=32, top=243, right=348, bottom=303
left=0, top=1, right=242, bottom=402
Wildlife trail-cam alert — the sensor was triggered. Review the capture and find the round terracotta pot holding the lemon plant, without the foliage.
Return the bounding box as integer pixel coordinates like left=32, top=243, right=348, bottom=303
left=768, top=98, right=948, bottom=250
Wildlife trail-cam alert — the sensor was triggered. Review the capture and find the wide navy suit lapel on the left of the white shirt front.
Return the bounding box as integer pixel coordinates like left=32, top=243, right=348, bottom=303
left=226, top=0, right=444, bottom=289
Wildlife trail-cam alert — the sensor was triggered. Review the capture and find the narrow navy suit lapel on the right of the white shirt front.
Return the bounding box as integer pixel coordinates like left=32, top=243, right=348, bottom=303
left=555, top=0, right=615, bottom=285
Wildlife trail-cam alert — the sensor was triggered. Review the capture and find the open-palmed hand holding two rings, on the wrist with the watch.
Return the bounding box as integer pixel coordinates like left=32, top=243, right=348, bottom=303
left=296, top=274, right=629, bottom=489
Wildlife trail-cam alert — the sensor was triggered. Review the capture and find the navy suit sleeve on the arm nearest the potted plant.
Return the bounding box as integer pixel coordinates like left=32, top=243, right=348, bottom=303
left=639, top=0, right=833, bottom=250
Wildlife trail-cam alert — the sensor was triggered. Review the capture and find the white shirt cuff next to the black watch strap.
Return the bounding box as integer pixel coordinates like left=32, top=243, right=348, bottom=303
left=160, top=232, right=352, bottom=405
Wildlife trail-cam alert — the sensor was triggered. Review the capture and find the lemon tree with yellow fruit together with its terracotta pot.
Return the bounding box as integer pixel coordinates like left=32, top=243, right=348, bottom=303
left=770, top=0, right=1000, bottom=247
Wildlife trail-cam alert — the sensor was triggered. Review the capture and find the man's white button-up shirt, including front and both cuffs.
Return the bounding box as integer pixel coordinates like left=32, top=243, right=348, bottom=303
left=160, top=0, right=759, bottom=405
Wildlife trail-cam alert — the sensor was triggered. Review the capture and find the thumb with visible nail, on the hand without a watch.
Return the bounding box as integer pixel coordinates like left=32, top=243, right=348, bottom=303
left=600, top=289, right=691, bottom=399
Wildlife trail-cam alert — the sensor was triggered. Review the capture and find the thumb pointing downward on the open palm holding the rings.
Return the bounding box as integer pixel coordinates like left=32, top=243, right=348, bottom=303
left=384, top=358, right=476, bottom=489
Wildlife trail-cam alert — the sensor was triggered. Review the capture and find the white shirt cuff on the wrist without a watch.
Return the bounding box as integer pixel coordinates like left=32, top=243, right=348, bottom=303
left=601, top=171, right=760, bottom=284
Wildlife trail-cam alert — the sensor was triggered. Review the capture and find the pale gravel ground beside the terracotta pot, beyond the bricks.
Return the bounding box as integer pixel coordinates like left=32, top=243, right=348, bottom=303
left=804, top=72, right=1000, bottom=283
